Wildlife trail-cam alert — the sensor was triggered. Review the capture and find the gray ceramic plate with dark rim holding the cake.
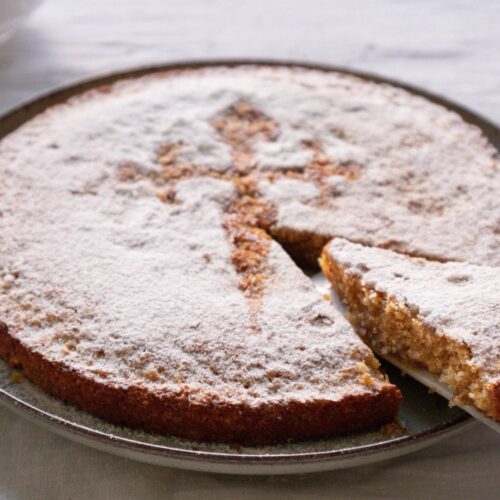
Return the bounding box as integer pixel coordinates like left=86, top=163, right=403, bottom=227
left=0, top=61, right=500, bottom=474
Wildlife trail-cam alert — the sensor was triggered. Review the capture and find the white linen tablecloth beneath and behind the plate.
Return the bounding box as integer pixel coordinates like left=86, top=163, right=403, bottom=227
left=0, top=0, right=500, bottom=499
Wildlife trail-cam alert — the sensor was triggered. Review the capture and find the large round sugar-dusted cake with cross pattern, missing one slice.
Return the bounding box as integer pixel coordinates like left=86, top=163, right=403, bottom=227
left=0, top=66, right=500, bottom=444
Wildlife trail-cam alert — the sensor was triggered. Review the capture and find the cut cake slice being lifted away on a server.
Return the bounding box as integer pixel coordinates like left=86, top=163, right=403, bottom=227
left=322, top=239, right=500, bottom=421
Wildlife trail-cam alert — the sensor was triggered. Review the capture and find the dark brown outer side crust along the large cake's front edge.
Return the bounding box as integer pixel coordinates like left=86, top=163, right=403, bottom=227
left=0, top=322, right=401, bottom=445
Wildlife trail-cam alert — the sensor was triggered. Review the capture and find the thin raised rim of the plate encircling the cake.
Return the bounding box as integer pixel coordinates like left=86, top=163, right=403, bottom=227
left=0, top=58, right=500, bottom=465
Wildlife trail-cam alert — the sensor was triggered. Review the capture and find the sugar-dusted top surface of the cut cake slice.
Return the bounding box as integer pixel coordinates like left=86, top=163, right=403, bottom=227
left=327, top=238, right=500, bottom=379
